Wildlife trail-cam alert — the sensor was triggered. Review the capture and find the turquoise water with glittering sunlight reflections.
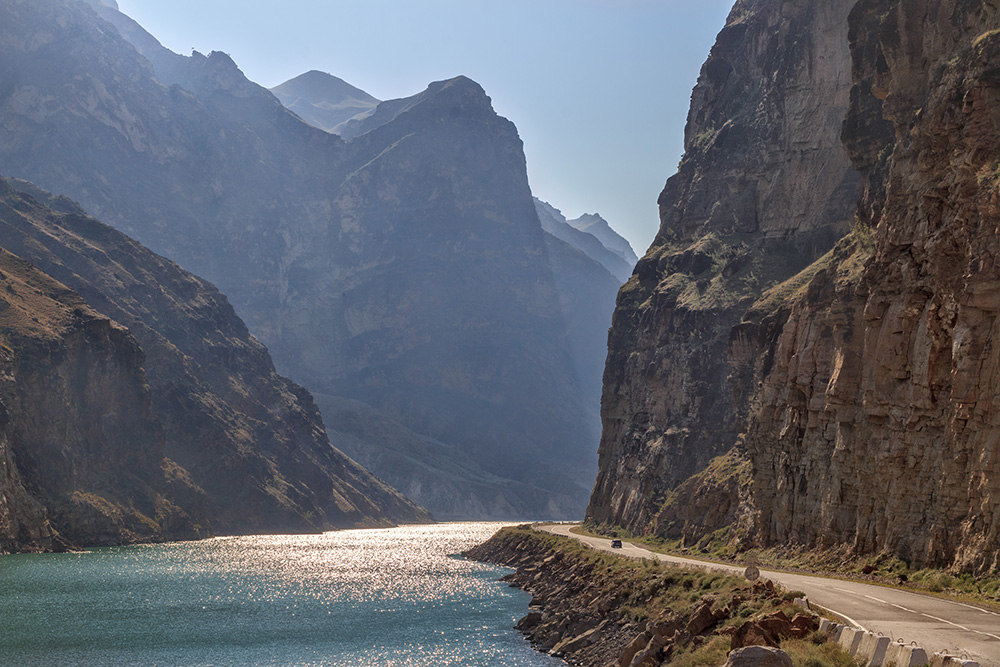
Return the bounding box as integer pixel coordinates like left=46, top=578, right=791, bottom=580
left=0, top=523, right=563, bottom=667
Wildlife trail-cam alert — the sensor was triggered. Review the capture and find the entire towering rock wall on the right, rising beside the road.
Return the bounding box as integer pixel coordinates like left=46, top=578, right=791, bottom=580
left=588, top=0, right=1000, bottom=574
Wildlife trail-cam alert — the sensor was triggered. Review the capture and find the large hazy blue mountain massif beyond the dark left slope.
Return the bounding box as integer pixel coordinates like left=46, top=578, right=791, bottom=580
left=0, top=0, right=607, bottom=518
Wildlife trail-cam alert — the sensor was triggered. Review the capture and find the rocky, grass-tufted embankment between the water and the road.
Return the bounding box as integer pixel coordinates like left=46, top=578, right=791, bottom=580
left=464, top=526, right=853, bottom=667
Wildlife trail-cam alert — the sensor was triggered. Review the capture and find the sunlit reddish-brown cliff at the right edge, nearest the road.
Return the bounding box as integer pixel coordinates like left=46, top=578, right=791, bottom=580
left=747, top=0, right=1000, bottom=571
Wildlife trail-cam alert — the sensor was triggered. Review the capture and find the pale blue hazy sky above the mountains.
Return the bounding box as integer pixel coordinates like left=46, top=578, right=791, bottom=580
left=118, top=0, right=733, bottom=256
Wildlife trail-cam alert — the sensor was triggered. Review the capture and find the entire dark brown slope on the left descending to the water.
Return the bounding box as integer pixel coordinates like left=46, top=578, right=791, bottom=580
left=0, top=175, right=429, bottom=550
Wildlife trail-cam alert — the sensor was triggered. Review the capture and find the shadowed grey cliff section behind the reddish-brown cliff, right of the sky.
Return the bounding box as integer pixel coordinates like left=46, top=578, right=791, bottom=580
left=588, top=0, right=860, bottom=530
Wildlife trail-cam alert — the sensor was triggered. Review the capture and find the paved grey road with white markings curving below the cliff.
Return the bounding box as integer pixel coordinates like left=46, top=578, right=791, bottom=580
left=539, top=524, right=1000, bottom=667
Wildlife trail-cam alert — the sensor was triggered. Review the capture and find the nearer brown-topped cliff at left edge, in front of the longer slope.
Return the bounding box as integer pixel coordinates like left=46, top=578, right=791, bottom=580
left=0, top=237, right=204, bottom=552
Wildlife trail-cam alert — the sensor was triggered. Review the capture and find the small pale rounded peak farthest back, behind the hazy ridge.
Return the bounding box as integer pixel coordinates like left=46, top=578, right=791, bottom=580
left=271, top=70, right=379, bottom=133
